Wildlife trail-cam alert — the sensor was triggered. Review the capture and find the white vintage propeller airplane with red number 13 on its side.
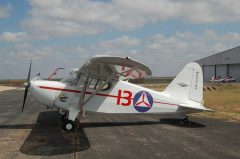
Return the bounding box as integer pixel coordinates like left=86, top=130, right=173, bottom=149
left=22, top=56, right=210, bottom=131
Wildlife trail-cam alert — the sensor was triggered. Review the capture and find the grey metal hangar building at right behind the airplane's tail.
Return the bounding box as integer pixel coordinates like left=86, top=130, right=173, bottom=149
left=196, top=46, right=240, bottom=82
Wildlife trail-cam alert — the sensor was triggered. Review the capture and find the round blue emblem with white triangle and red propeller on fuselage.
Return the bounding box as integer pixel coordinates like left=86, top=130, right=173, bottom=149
left=133, top=91, right=153, bottom=112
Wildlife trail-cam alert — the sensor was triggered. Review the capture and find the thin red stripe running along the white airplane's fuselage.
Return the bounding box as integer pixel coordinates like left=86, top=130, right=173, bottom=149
left=39, top=86, right=177, bottom=106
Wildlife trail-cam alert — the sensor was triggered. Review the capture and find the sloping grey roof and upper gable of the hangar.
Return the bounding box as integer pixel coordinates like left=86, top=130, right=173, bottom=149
left=196, top=46, right=240, bottom=65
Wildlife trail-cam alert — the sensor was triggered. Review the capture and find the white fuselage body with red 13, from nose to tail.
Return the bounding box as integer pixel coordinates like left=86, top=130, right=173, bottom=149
left=30, top=80, right=192, bottom=114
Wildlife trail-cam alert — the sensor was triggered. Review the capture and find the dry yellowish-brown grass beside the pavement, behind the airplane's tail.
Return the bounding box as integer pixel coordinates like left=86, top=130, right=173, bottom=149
left=141, top=83, right=240, bottom=121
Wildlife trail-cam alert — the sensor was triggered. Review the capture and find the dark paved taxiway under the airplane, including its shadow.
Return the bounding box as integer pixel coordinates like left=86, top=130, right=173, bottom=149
left=0, top=90, right=240, bottom=159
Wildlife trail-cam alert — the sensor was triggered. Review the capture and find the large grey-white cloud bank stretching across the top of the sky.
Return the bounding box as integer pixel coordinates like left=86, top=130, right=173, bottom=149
left=22, top=0, right=240, bottom=38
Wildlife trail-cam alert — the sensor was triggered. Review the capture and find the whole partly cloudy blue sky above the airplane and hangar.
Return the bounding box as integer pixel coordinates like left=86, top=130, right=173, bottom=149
left=0, top=0, right=240, bottom=79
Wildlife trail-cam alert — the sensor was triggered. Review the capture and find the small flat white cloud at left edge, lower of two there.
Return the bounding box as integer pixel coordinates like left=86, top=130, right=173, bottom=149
left=0, top=32, right=28, bottom=42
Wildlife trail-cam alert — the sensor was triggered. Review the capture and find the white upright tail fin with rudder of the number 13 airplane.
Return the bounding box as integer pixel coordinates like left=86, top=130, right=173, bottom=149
left=164, top=62, right=203, bottom=106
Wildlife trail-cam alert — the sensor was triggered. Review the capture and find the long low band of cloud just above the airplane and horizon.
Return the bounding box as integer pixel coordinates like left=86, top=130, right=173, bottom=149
left=0, top=30, right=240, bottom=78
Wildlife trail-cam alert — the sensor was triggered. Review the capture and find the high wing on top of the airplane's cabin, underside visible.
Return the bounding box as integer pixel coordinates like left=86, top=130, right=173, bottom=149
left=80, top=56, right=152, bottom=80
